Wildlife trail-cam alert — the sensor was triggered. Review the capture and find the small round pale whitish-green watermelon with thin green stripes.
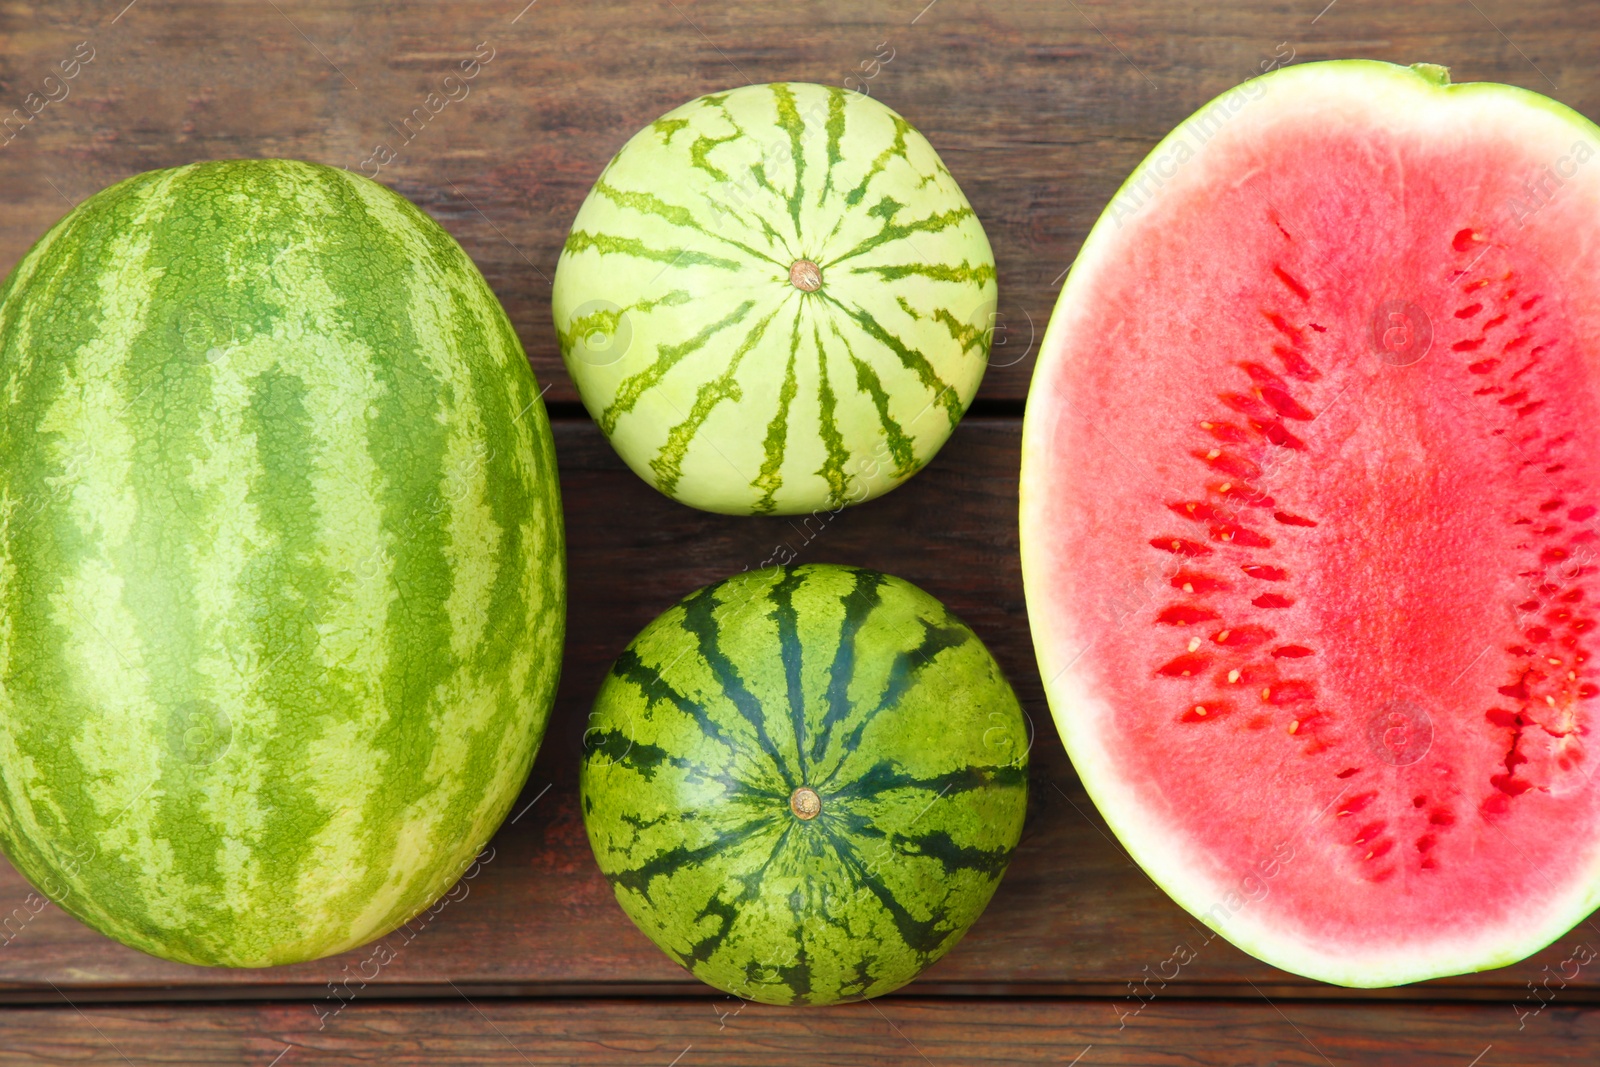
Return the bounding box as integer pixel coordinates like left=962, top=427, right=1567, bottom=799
left=552, top=83, right=997, bottom=515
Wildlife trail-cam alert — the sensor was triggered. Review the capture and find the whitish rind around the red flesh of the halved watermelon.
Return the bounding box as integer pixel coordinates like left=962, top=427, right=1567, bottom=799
left=1019, top=61, right=1600, bottom=989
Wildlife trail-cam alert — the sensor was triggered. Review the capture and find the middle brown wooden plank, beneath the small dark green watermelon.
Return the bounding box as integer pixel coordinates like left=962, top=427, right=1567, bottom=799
left=0, top=419, right=1600, bottom=1008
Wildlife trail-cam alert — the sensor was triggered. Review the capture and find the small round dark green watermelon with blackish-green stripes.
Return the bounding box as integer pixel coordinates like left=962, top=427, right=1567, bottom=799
left=579, top=565, right=1029, bottom=1005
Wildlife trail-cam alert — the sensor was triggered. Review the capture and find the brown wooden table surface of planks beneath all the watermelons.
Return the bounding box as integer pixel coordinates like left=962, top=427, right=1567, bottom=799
left=0, top=0, right=1600, bottom=1067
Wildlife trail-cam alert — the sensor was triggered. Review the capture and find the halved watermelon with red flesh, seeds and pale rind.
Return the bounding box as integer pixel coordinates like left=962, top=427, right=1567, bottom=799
left=1022, top=62, right=1600, bottom=985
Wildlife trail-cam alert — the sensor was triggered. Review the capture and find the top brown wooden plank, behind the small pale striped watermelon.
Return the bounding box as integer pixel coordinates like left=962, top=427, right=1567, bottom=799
left=0, top=0, right=1600, bottom=402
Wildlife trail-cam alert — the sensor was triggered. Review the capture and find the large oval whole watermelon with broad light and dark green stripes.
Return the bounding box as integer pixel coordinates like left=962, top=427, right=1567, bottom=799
left=0, top=160, right=565, bottom=966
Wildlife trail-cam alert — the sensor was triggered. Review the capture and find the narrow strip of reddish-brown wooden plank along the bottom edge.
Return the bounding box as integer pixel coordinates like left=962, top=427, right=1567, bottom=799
left=0, top=997, right=1600, bottom=1067
